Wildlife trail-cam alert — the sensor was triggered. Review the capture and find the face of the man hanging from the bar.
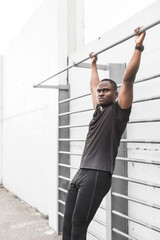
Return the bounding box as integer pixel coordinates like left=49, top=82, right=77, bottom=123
left=97, top=81, right=118, bottom=108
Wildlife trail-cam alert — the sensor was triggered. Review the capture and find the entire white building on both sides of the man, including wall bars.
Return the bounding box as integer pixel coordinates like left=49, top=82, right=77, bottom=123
left=0, top=0, right=160, bottom=240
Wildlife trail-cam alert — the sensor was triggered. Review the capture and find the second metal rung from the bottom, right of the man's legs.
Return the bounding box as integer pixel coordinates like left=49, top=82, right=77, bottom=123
left=112, top=210, right=160, bottom=232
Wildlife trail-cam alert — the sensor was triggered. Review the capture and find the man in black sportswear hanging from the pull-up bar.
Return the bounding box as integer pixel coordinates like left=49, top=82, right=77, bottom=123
left=63, top=27, right=145, bottom=240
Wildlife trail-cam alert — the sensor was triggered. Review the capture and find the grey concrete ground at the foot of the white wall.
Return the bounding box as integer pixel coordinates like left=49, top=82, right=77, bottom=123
left=0, top=185, right=61, bottom=240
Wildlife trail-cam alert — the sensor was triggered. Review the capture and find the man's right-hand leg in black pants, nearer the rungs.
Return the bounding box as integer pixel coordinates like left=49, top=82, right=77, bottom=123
left=71, top=169, right=111, bottom=240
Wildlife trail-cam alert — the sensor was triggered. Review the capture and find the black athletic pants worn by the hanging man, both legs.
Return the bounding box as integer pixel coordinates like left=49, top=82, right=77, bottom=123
left=63, top=169, right=112, bottom=240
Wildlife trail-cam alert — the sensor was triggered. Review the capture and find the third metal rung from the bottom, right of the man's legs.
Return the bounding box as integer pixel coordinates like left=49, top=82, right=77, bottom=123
left=112, top=192, right=160, bottom=210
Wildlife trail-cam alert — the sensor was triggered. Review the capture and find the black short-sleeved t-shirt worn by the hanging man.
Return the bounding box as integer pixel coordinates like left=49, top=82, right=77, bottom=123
left=80, top=102, right=131, bottom=173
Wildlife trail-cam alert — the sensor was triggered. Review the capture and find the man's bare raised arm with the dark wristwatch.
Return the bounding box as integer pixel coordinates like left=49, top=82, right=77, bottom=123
left=118, top=27, right=145, bottom=109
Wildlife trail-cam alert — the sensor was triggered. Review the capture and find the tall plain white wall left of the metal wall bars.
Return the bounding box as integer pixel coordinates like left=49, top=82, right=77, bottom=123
left=0, top=0, right=84, bottom=231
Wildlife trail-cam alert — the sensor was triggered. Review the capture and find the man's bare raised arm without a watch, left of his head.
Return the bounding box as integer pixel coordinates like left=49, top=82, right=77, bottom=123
left=89, top=53, right=99, bottom=109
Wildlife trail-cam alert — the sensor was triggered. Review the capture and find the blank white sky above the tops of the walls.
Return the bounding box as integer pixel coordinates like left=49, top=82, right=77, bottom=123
left=0, top=0, right=155, bottom=55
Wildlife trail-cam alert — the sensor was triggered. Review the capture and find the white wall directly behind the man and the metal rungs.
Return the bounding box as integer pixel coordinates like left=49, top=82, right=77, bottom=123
left=69, top=1, right=160, bottom=240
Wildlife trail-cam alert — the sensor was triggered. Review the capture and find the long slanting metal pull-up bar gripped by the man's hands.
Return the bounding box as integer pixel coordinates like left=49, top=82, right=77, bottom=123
left=34, top=20, right=160, bottom=87
